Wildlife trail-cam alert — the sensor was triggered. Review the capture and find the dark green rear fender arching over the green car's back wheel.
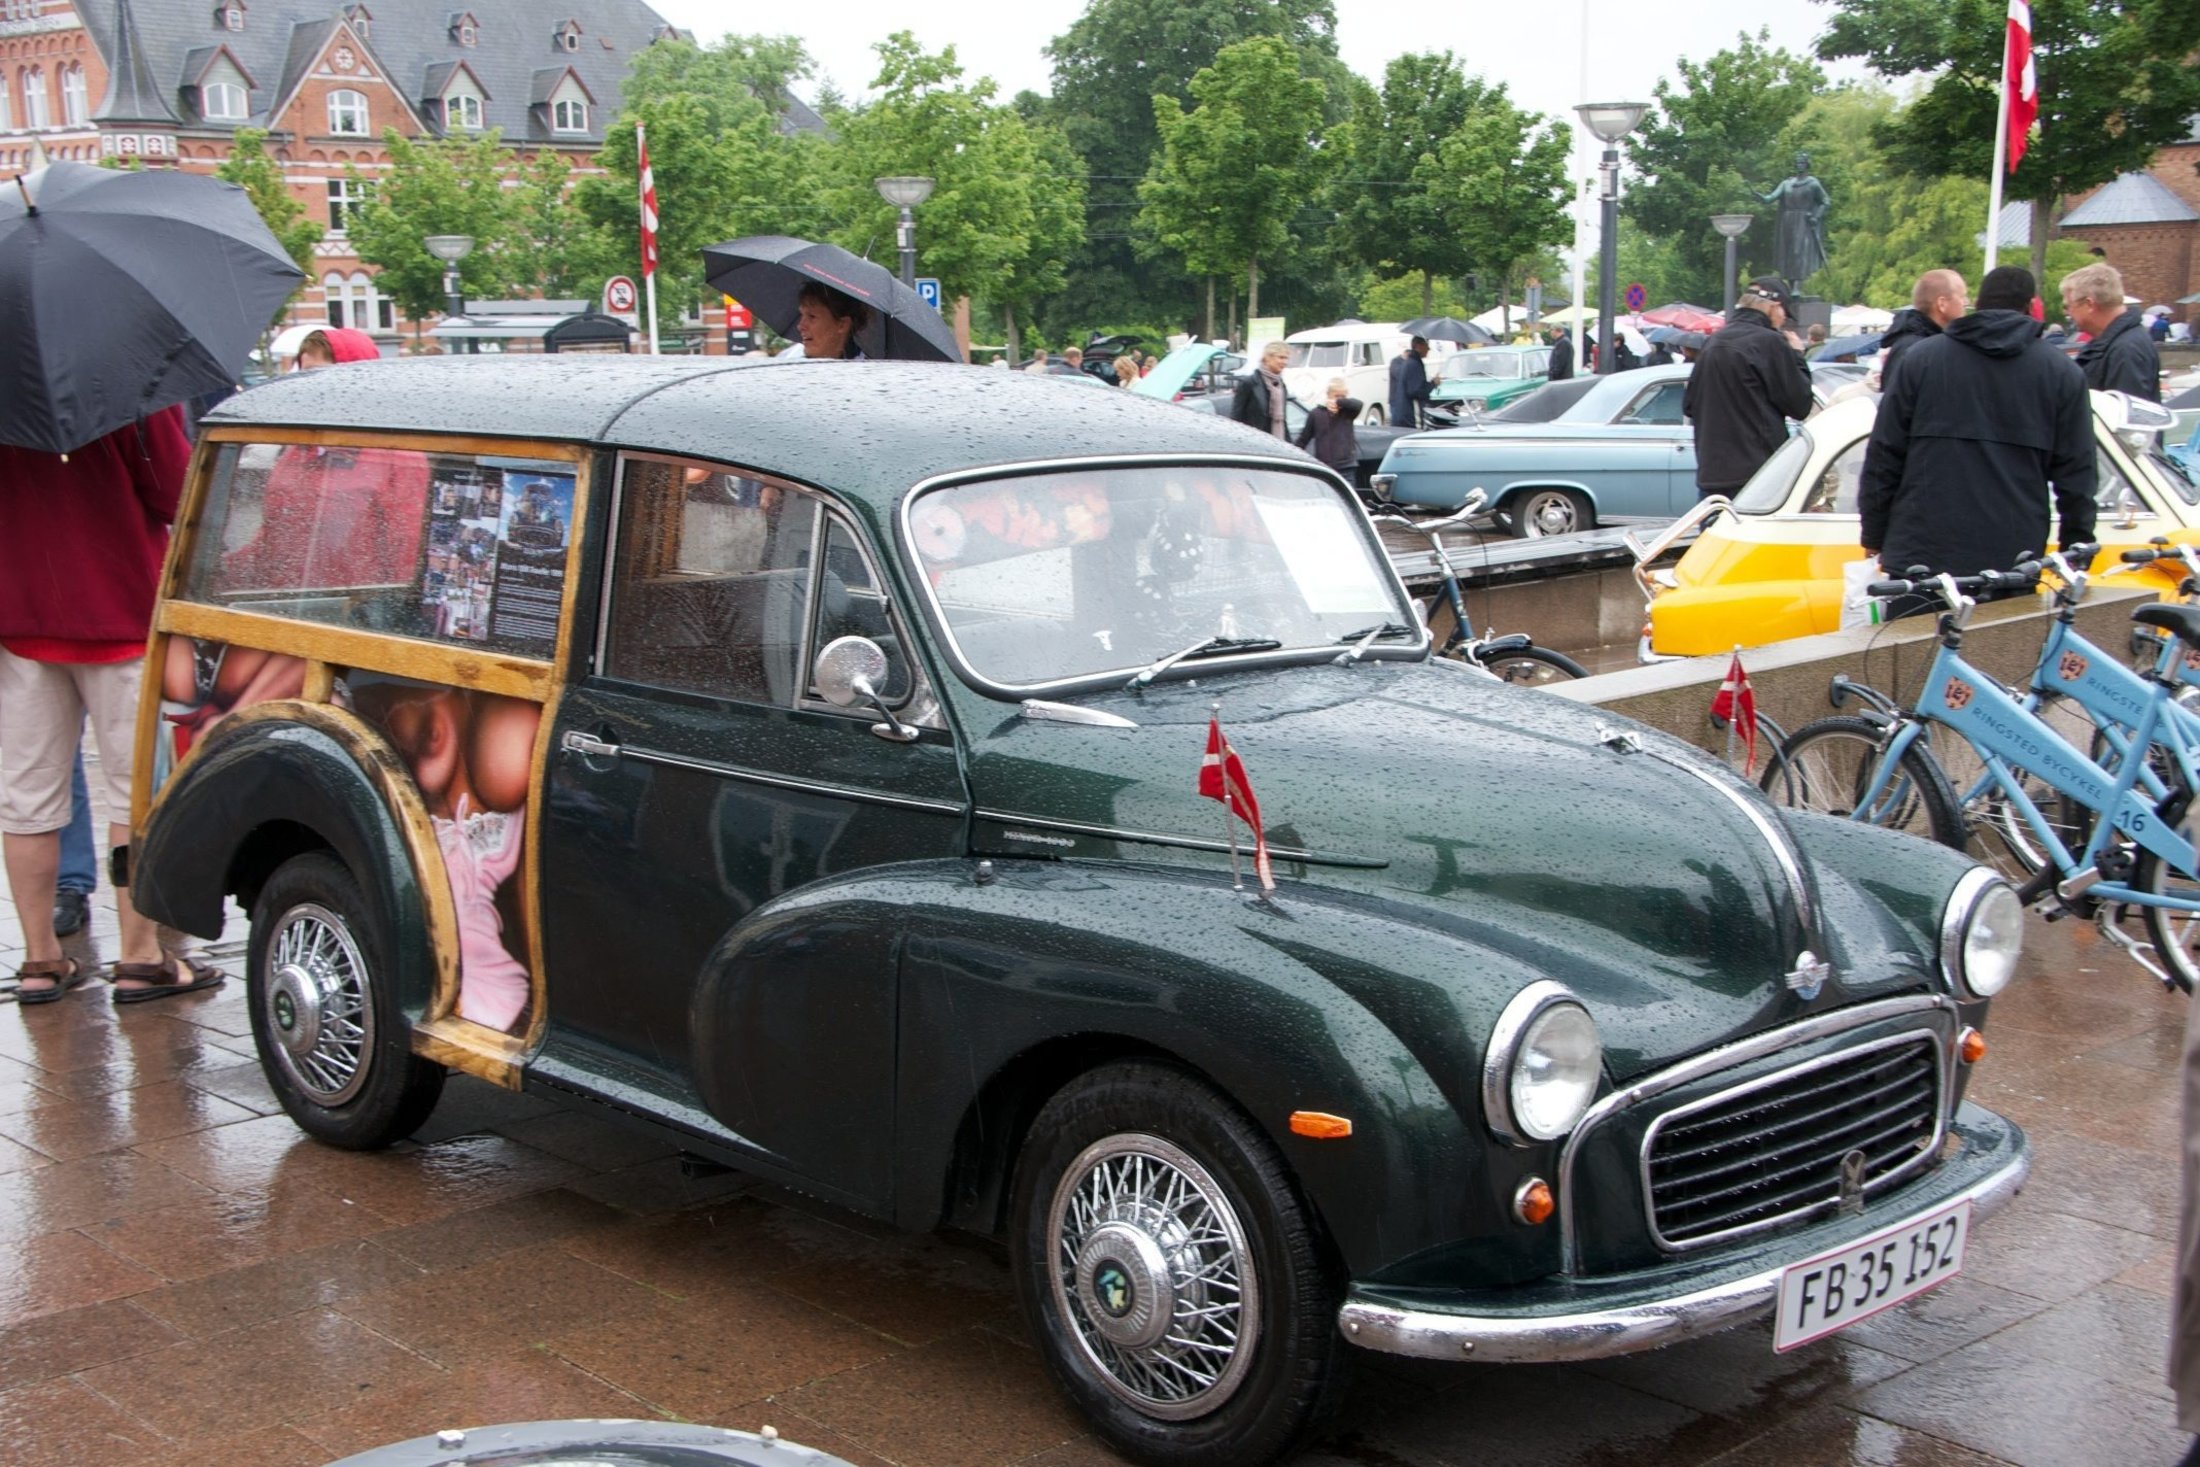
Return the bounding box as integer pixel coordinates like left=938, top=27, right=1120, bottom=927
left=130, top=702, right=436, bottom=1021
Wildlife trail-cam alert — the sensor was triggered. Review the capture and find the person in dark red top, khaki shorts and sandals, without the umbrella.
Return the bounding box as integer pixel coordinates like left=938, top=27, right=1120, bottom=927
left=0, top=407, right=222, bottom=1005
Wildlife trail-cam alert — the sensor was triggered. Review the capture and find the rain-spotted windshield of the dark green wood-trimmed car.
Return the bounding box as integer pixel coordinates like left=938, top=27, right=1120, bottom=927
left=909, top=464, right=1417, bottom=691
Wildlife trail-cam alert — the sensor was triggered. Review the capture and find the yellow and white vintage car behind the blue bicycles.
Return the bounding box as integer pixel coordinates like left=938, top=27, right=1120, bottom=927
left=1628, top=391, right=2200, bottom=662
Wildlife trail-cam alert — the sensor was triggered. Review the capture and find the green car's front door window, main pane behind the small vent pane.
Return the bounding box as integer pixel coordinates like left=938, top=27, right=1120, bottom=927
left=603, top=457, right=818, bottom=706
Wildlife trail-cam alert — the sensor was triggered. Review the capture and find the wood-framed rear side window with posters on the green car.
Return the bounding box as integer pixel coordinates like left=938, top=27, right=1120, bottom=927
left=183, top=444, right=574, bottom=658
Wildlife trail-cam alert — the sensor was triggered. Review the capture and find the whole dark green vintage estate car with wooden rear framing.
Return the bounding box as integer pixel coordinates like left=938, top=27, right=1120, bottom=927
left=134, top=359, right=2026, bottom=1463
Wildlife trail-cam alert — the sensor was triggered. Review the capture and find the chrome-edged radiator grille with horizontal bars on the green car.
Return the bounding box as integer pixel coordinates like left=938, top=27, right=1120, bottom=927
left=1643, top=1034, right=1943, bottom=1247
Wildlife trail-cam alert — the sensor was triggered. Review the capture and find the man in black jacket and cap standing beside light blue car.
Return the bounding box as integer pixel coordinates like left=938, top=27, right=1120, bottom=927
left=1681, top=275, right=1811, bottom=499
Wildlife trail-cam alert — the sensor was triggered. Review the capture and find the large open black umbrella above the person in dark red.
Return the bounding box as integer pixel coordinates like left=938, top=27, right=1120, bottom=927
left=0, top=163, right=306, bottom=453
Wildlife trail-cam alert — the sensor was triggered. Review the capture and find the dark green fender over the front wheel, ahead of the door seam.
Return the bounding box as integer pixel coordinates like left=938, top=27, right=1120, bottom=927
left=866, top=860, right=1558, bottom=1284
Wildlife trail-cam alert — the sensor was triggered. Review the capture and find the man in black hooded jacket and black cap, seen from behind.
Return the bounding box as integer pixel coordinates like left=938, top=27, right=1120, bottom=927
left=1857, top=264, right=2097, bottom=616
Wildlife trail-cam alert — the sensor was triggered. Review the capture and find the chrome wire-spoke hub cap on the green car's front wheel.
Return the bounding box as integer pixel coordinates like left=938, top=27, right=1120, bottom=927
left=1047, top=1135, right=1261, bottom=1421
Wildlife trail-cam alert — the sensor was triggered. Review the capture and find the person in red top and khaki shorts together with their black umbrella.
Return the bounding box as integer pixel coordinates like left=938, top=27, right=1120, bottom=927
left=0, top=163, right=304, bottom=1005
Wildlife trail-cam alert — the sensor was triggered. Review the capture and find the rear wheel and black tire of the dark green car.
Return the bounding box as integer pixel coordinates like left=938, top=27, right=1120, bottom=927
left=244, top=851, right=444, bottom=1150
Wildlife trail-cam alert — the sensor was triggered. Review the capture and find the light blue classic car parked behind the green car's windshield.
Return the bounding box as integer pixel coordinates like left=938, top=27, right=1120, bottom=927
left=1368, top=363, right=1859, bottom=539
